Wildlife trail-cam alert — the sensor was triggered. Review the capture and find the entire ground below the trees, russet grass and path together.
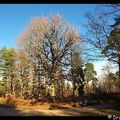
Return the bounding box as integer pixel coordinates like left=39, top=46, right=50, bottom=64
left=0, top=96, right=120, bottom=116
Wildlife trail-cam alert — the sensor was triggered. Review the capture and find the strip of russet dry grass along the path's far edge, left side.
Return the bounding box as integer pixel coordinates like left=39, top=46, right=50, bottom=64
left=0, top=97, right=76, bottom=109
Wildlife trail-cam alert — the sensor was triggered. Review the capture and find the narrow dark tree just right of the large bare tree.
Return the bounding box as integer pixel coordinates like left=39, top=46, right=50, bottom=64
left=71, top=50, right=85, bottom=98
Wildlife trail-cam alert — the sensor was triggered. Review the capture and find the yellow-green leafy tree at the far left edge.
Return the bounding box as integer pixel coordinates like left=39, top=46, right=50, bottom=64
left=0, top=47, right=15, bottom=92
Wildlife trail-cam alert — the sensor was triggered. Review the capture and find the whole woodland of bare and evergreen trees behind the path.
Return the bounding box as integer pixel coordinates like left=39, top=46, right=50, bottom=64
left=0, top=4, right=120, bottom=115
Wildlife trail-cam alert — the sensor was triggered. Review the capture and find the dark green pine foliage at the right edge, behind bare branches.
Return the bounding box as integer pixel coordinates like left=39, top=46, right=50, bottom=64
left=103, top=17, right=120, bottom=77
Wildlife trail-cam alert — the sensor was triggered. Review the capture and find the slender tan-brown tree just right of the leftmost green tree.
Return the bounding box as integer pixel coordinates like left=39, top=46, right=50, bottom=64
left=15, top=49, right=31, bottom=98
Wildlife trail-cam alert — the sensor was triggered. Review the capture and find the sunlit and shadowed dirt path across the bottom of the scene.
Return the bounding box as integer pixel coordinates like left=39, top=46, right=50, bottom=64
left=0, top=106, right=120, bottom=116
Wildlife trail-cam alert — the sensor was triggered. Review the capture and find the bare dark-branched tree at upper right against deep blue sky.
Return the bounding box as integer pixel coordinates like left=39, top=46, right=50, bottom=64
left=86, top=5, right=120, bottom=78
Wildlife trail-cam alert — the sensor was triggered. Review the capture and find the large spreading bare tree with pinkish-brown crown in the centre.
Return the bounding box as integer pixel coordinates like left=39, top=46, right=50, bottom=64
left=18, top=14, right=79, bottom=101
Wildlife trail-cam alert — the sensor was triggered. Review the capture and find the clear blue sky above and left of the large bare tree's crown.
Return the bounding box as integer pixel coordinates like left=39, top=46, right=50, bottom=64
left=0, top=4, right=99, bottom=48
